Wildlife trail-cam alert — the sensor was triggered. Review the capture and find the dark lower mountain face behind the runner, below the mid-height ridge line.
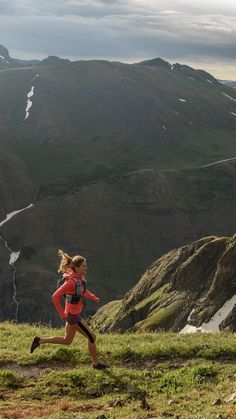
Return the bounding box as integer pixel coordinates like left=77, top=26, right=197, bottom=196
left=0, top=161, right=236, bottom=324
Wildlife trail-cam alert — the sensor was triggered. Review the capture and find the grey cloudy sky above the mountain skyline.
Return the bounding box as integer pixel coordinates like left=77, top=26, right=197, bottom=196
left=0, top=0, right=236, bottom=80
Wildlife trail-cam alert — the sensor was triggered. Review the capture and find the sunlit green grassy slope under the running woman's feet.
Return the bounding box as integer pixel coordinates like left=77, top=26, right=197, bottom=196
left=0, top=323, right=236, bottom=419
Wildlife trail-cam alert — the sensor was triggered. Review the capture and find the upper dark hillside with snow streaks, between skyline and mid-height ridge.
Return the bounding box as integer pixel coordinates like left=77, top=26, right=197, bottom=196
left=0, top=55, right=236, bottom=197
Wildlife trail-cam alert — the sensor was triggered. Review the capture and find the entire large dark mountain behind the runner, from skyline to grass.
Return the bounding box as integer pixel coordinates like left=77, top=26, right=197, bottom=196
left=0, top=46, right=236, bottom=324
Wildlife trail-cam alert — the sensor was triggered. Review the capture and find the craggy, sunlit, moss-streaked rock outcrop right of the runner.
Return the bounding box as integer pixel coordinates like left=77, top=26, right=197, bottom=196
left=94, top=235, right=236, bottom=332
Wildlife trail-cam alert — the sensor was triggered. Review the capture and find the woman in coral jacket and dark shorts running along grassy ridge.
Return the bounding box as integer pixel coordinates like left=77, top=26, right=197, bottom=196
left=30, top=250, right=108, bottom=369
